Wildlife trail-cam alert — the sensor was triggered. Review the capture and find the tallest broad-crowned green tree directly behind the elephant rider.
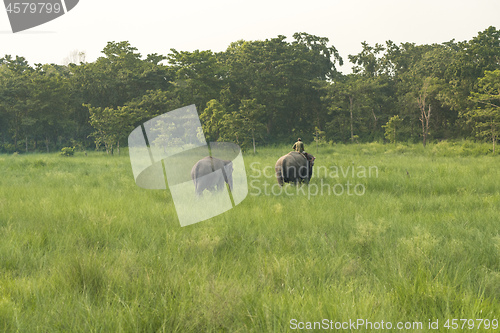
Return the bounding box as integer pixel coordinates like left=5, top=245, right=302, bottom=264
left=223, top=33, right=342, bottom=139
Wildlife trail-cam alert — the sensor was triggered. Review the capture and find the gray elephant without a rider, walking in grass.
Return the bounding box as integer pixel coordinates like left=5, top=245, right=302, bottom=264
left=191, top=156, right=233, bottom=196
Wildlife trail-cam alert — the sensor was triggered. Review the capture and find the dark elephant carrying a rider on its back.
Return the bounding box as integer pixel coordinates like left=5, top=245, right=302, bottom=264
left=274, top=151, right=316, bottom=186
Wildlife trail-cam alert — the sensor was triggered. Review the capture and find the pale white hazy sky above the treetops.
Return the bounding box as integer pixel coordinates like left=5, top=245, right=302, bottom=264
left=0, top=0, right=500, bottom=73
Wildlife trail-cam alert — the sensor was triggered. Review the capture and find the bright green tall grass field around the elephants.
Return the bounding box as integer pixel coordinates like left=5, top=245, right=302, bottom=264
left=0, top=142, right=500, bottom=332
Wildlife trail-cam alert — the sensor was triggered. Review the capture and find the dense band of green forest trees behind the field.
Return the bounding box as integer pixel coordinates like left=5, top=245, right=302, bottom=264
left=0, top=27, right=500, bottom=153
